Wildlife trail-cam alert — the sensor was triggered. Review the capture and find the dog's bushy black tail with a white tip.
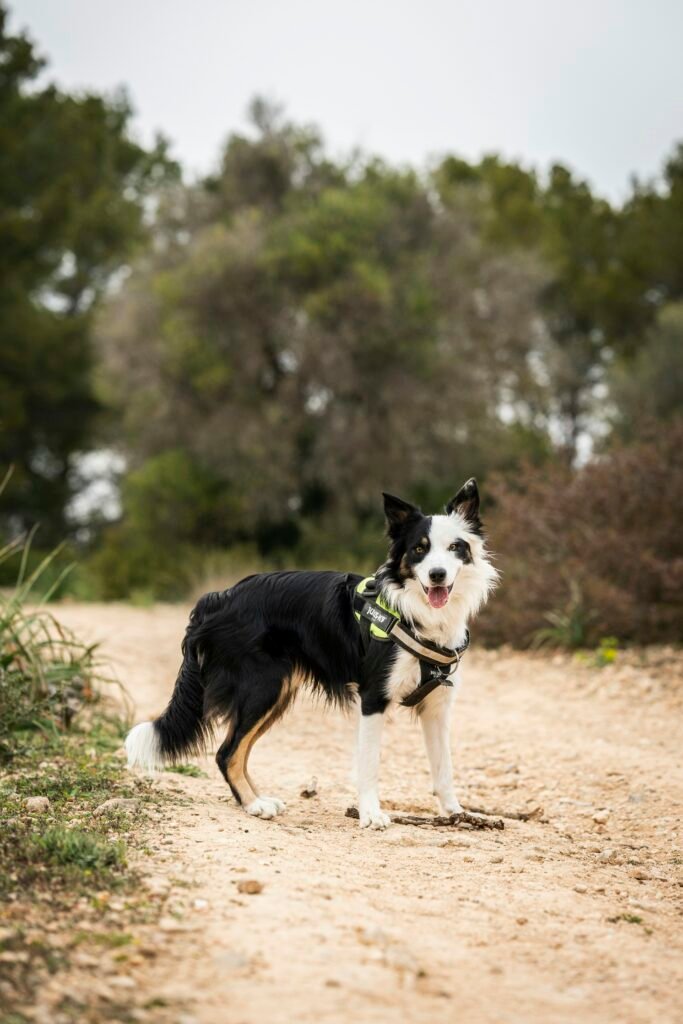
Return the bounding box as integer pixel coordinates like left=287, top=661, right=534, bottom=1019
left=126, top=591, right=229, bottom=771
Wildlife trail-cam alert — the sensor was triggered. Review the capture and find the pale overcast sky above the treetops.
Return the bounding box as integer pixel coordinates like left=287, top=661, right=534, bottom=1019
left=10, top=0, right=683, bottom=200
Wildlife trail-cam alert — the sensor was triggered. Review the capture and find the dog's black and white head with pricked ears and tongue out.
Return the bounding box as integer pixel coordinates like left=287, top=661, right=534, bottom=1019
left=380, top=478, right=498, bottom=623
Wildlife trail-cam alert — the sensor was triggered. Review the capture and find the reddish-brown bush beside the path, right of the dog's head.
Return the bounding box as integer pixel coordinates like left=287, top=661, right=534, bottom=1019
left=479, top=419, right=683, bottom=646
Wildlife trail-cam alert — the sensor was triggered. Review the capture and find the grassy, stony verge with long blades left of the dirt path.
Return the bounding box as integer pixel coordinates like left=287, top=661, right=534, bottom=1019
left=0, top=484, right=179, bottom=1024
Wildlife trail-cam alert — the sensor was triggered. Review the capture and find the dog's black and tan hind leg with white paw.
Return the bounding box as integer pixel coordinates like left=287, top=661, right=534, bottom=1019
left=216, top=676, right=295, bottom=818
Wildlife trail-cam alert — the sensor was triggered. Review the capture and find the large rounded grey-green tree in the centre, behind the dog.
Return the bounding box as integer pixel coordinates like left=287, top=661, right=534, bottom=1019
left=100, top=111, right=547, bottom=589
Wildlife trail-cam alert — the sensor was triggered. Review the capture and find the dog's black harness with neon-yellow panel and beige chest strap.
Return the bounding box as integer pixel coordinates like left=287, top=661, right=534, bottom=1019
left=353, top=577, right=470, bottom=708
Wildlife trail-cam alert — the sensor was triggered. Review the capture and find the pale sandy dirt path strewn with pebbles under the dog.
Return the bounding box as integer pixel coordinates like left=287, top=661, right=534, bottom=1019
left=60, top=606, right=683, bottom=1024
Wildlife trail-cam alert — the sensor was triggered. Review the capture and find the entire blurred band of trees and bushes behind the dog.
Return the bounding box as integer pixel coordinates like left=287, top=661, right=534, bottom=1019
left=0, top=3, right=683, bottom=646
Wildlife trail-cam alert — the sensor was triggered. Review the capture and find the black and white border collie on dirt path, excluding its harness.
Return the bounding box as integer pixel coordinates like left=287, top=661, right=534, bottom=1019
left=126, top=479, right=498, bottom=828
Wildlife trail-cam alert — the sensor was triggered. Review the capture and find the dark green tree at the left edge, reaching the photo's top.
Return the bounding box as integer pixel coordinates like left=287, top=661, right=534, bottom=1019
left=0, top=5, right=174, bottom=541
